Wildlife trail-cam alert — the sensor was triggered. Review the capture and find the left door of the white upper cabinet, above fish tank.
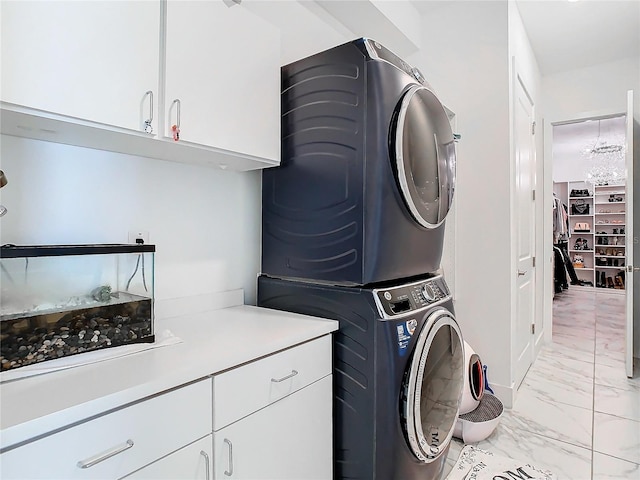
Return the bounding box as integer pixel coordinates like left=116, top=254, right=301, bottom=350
left=0, top=0, right=160, bottom=130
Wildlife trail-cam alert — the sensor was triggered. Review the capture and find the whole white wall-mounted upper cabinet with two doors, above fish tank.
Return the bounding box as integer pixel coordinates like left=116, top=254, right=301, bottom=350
left=0, top=0, right=280, bottom=171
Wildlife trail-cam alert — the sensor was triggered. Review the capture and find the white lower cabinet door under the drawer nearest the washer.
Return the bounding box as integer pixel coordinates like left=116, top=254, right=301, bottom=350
left=213, top=375, right=333, bottom=480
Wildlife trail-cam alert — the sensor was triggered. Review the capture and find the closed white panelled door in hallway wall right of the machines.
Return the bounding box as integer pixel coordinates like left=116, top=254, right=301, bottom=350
left=513, top=70, right=536, bottom=386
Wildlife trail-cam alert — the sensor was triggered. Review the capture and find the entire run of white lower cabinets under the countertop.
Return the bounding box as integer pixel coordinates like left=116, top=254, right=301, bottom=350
left=0, top=335, right=333, bottom=480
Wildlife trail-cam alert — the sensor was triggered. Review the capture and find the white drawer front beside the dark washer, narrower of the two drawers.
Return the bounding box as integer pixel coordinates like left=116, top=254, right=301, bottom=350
left=213, top=335, right=331, bottom=431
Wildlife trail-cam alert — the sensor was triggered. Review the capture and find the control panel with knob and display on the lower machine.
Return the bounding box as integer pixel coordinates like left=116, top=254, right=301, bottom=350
left=373, top=276, right=451, bottom=318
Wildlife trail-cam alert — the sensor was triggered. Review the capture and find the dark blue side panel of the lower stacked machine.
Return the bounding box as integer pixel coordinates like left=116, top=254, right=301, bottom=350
left=258, top=276, right=390, bottom=480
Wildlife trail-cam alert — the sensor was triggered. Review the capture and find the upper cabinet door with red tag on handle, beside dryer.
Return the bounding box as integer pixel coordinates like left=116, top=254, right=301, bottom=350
left=165, top=0, right=280, bottom=161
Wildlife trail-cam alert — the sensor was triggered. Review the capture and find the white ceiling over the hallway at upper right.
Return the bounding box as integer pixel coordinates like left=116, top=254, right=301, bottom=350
left=516, top=0, right=640, bottom=75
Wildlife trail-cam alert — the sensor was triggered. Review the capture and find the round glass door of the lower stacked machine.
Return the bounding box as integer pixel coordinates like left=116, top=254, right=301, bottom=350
left=400, top=309, right=464, bottom=463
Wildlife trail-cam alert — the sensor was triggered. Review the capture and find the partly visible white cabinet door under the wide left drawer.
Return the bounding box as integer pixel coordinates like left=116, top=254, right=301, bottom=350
left=123, top=435, right=213, bottom=480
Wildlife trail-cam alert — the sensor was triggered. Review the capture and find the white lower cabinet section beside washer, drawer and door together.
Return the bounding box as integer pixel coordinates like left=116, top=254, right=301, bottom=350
left=213, top=335, right=333, bottom=480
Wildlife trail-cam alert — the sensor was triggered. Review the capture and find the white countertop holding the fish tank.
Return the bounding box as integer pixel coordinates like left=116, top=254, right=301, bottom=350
left=0, top=305, right=338, bottom=449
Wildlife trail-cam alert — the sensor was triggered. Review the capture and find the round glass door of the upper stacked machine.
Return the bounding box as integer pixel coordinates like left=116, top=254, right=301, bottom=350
left=391, top=85, right=456, bottom=228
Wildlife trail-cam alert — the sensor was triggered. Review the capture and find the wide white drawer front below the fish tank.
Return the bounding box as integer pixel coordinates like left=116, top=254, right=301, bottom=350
left=0, top=380, right=212, bottom=480
